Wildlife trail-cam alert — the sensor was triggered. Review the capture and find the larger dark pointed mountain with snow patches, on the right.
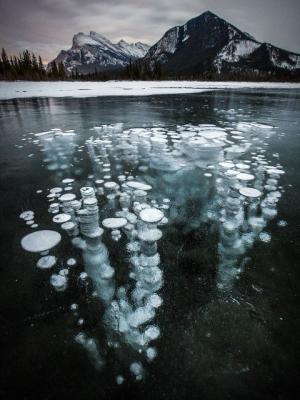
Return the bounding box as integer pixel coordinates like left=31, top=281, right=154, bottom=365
left=145, top=11, right=300, bottom=77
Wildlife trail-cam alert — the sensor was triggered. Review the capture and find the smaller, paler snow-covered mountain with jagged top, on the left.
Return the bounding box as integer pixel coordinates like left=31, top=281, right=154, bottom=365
left=48, top=31, right=150, bottom=74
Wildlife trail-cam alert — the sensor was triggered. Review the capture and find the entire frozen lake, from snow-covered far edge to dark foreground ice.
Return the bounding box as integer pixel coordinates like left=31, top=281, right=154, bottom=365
left=0, top=82, right=300, bottom=400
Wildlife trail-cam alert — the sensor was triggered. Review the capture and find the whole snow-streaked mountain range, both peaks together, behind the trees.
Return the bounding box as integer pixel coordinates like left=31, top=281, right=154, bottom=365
left=50, top=11, right=300, bottom=77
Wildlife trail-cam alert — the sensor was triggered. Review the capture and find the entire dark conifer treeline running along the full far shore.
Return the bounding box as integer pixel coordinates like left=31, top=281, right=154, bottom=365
left=0, top=49, right=300, bottom=82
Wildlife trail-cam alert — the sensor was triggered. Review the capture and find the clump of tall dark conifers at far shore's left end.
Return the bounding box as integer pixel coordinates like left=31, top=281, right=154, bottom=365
left=0, top=49, right=67, bottom=81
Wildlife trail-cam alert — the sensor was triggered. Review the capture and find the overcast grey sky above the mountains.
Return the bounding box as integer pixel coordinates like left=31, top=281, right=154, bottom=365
left=0, top=0, right=300, bottom=61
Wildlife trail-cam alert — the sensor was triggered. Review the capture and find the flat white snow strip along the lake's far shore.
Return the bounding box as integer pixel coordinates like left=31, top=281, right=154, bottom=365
left=0, top=81, right=300, bottom=100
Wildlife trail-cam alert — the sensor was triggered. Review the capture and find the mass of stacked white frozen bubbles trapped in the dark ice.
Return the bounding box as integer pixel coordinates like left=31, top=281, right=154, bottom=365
left=17, top=115, right=284, bottom=383
